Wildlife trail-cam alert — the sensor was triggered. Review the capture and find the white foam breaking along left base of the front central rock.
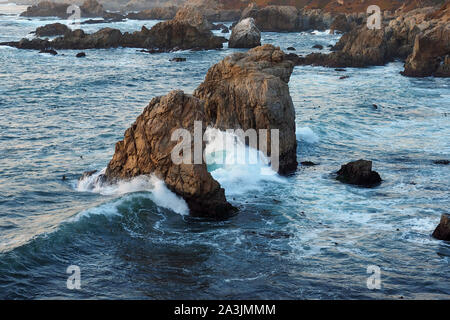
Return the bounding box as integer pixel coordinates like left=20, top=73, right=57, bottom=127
left=76, top=168, right=189, bottom=215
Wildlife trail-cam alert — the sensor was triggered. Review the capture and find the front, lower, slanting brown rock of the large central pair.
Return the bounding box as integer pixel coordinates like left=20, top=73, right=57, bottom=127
left=105, top=91, right=236, bottom=219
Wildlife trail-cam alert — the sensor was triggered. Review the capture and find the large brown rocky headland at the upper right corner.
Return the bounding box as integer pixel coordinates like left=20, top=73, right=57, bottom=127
left=299, top=3, right=450, bottom=76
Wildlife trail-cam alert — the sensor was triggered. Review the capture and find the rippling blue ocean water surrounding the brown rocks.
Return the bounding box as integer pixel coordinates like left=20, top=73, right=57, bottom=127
left=0, top=4, right=450, bottom=299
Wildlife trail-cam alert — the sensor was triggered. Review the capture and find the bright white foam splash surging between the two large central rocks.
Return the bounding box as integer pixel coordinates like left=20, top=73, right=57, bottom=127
left=205, top=128, right=285, bottom=195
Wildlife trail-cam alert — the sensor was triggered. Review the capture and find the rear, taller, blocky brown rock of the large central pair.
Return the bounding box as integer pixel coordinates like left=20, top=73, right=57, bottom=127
left=194, top=44, right=297, bottom=174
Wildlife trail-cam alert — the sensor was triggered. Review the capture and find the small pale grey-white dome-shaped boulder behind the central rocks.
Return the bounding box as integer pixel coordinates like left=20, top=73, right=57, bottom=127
left=228, top=18, right=261, bottom=48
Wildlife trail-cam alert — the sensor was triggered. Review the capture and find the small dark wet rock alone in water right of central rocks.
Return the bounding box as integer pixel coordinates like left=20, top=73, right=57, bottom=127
left=336, top=159, right=382, bottom=186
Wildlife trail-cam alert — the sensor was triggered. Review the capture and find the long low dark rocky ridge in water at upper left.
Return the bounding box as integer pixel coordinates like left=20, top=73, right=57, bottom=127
left=2, top=7, right=226, bottom=52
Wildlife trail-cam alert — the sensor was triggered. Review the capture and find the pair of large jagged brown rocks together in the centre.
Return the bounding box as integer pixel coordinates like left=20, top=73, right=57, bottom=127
left=105, top=45, right=297, bottom=219
